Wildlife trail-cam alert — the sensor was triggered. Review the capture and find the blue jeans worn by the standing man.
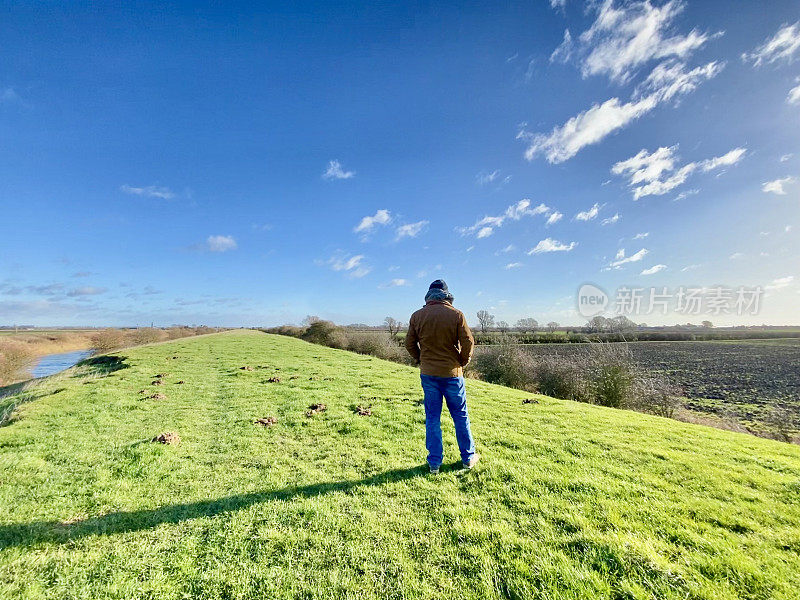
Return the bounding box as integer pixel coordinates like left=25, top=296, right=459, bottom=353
left=420, top=375, right=475, bottom=469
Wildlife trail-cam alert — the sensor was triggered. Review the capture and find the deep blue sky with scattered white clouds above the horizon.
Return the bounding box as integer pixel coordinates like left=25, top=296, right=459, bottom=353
left=0, top=0, right=800, bottom=326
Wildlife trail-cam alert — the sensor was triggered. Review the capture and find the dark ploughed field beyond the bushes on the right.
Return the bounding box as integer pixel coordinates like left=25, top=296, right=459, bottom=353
left=526, top=338, right=800, bottom=430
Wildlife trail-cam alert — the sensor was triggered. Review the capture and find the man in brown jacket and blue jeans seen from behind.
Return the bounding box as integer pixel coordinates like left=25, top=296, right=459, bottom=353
left=406, top=279, right=480, bottom=474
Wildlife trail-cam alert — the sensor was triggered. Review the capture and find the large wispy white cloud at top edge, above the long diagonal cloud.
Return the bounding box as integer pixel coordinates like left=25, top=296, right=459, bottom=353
left=552, top=0, right=712, bottom=82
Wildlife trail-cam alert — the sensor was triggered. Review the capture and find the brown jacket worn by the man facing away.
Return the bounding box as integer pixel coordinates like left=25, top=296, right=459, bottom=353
left=406, top=300, right=475, bottom=377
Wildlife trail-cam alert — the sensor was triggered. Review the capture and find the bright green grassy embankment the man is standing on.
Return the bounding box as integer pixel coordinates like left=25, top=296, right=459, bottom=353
left=0, top=332, right=800, bottom=599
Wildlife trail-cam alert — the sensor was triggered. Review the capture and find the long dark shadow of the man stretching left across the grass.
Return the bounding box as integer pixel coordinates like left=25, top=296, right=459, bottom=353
left=0, top=461, right=468, bottom=550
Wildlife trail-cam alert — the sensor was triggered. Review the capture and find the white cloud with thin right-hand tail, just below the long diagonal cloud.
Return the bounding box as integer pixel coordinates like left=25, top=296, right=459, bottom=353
left=611, top=146, right=747, bottom=200
